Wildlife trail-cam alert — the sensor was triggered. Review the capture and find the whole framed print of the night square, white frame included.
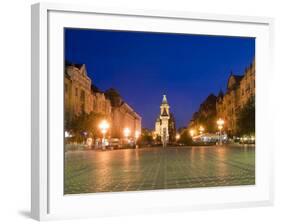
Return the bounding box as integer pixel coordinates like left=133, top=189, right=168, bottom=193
left=31, top=3, right=273, bottom=220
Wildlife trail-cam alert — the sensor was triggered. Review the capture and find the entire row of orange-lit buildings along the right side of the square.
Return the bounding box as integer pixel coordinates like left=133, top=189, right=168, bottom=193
left=188, top=60, right=255, bottom=135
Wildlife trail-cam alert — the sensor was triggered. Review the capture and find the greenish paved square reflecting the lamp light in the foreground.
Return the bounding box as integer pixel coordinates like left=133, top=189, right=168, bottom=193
left=65, top=146, right=255, bottom=194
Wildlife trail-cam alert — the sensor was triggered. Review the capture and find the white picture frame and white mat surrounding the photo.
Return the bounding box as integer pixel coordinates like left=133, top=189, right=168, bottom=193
left=31, top=3, right=273, bottom=220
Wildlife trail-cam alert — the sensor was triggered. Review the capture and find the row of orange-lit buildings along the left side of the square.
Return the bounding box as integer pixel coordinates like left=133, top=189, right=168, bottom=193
left=64, top=62, right=142, bottom=138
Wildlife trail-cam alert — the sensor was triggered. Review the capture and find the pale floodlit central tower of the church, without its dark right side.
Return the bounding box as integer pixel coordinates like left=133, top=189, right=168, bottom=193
left=155, top=95, right=170, bottom=147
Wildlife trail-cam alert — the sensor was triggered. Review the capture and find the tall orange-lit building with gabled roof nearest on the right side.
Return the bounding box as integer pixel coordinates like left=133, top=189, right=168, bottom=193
left=216, top=61, right=255, bottom=135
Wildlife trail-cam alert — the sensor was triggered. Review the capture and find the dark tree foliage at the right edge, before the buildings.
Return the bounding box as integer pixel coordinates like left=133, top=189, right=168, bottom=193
left=237, top=97, right=256, bottom=135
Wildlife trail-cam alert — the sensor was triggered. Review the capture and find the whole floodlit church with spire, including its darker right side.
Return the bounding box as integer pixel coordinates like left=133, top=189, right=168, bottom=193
left=155, top=95, right=175, bottom=146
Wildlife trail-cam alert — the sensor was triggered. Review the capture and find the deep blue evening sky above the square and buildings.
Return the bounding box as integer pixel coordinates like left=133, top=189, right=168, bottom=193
left=65, top=28, right=255, bottom=128
